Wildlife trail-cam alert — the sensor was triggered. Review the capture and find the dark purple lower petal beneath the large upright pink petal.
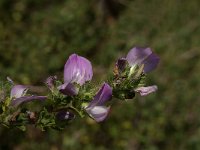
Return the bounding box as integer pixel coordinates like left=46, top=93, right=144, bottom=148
left=58, top=83, right=78, bottom=96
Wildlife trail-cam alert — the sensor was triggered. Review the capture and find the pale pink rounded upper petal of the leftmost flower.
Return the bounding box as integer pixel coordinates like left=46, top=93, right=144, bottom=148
left=10, top=85, right=28, bottom=98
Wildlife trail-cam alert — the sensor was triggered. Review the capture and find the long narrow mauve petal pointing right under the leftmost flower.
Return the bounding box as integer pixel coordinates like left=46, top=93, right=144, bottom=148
left=11, top=96, right=47, bottom=107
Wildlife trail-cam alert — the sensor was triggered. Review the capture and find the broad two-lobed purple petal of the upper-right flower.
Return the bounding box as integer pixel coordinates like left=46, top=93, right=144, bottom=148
left=126, top=47, right=160, bottom=73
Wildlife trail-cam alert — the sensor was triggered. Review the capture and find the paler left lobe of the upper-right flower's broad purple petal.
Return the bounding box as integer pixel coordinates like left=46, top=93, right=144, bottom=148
left=126, top=47, right=152, bottom=66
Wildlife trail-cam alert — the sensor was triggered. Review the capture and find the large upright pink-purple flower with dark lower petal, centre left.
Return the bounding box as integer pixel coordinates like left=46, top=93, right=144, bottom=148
left=58, top=54, right=93, bottom=96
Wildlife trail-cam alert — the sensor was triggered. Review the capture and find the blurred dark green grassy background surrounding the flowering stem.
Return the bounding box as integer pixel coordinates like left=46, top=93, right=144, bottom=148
left=0, top=0, right=200, bottom=150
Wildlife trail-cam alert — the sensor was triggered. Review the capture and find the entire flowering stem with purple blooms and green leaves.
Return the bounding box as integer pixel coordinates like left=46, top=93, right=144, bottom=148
left=0, top=47, right=159, bottom=130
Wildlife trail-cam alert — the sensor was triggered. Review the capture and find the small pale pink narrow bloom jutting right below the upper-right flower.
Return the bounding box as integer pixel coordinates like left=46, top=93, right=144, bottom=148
left=135, top=85, right=158, bottom=96
